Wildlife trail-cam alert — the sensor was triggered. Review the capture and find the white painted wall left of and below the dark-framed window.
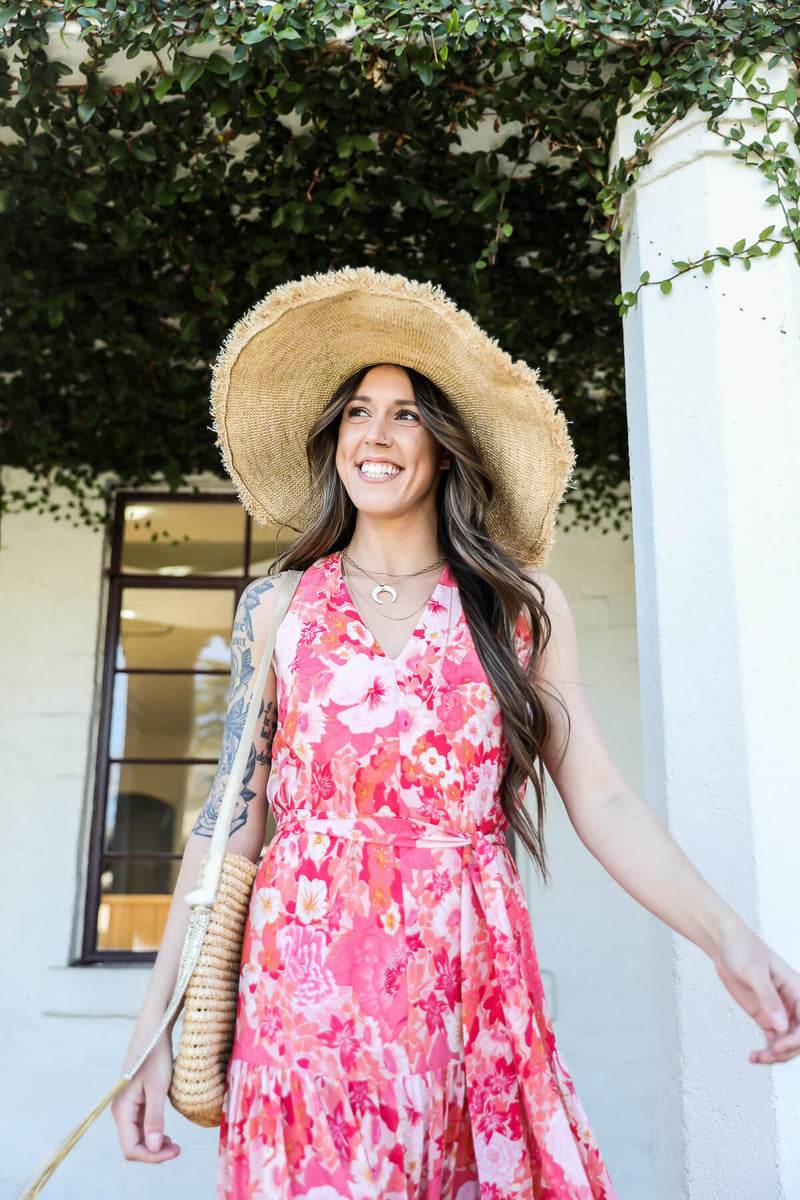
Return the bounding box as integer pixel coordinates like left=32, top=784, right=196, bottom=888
left=0, top=472, right=216, bottom=1200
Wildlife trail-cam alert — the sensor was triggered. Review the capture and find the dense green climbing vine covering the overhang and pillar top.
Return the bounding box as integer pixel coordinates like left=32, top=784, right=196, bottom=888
left=0, top=0, right=800, bottom=528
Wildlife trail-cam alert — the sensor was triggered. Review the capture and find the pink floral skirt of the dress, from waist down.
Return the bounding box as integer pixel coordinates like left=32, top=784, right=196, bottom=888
left=217, top=812, right=615, bottom=1200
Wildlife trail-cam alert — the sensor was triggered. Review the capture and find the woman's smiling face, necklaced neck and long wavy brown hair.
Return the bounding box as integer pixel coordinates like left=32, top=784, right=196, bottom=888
left=276, top=348, right=564, bottom=874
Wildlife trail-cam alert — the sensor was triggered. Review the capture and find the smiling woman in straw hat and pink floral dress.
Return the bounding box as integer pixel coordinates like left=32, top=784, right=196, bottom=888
left=114, top=270, right=800, bottom=1200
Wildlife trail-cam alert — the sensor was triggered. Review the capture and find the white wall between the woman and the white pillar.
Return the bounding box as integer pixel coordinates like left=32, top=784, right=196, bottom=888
left=521, top=518, right=673, bottom=1200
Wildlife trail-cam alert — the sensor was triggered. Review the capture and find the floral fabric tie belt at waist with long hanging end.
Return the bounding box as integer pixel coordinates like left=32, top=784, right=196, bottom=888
left=276, top=809, right=595, bottom=1200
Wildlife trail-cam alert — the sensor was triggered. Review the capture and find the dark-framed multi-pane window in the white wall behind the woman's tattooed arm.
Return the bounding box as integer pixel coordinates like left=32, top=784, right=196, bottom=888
left=80, top=492, right=294, bottom=962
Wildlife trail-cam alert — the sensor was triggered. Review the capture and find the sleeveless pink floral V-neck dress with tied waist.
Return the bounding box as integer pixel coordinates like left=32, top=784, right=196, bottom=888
left=217, top=554, right=615, bottom=1200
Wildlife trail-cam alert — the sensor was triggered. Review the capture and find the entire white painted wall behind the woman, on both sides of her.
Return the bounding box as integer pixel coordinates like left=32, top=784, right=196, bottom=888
left=0, top=472, right=657, bottom=1200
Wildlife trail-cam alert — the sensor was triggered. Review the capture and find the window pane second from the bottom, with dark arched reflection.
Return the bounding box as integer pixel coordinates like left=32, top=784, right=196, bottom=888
left=106, top=762, right=217, bottom=854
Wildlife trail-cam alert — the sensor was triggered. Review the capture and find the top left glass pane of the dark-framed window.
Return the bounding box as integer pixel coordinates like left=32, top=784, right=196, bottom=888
left=120, top=496, right=246, bottom=576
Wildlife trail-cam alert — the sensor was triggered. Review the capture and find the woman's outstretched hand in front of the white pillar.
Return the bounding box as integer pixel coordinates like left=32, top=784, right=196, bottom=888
left=714, top=925, right=800, bottom=1063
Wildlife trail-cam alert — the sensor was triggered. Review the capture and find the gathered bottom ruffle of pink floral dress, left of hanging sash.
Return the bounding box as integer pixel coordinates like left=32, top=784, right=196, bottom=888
left=219, top=1061, right=480, bottom=1200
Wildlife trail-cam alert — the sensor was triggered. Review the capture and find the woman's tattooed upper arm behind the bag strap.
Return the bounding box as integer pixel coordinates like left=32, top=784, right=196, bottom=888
left=192, top=575, right=281, bottom=838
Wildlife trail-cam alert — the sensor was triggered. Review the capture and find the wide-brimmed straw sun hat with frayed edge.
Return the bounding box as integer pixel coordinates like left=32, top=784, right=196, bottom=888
left=211, top=266, right=575, bottom=565
